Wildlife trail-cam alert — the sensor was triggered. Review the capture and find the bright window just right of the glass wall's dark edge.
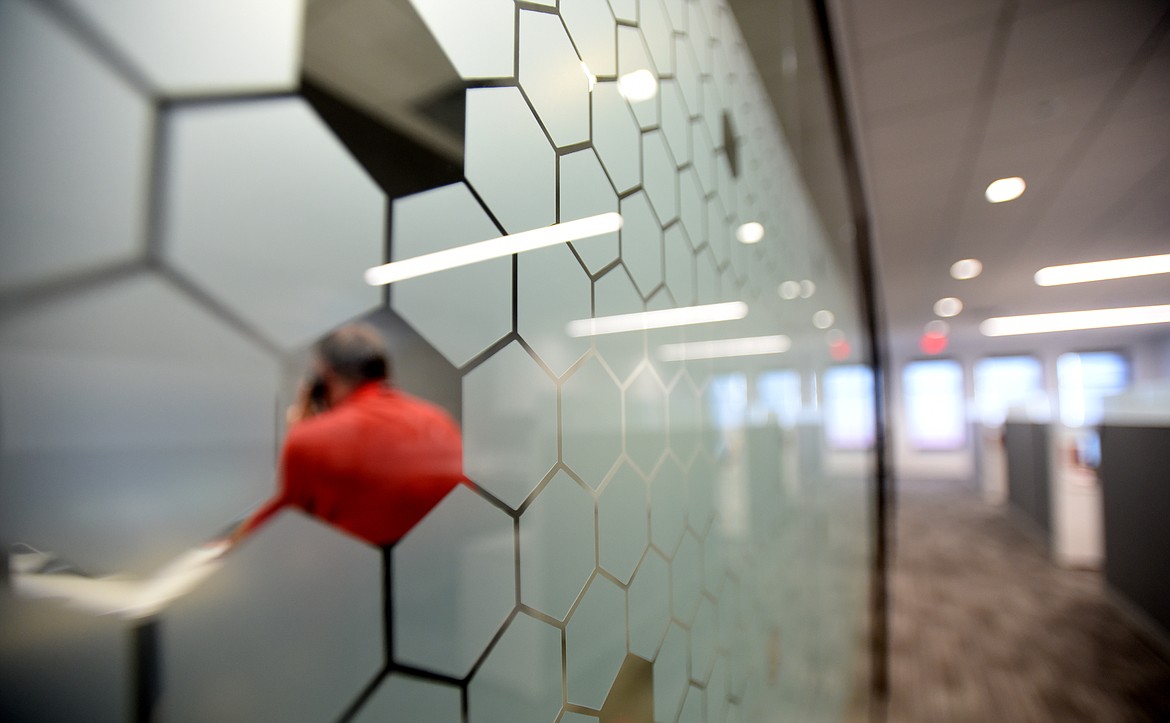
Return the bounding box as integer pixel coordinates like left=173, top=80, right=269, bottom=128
left=902, top=359, right=966, bottom=452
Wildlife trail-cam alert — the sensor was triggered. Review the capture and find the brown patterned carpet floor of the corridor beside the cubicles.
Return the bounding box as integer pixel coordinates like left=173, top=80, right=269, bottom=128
left=888, top=474, right=1170, bottom=723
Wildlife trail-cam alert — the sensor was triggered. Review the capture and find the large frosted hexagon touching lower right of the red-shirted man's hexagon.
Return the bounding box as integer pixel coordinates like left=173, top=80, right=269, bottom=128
left=391, top=484, right=516, bottom=677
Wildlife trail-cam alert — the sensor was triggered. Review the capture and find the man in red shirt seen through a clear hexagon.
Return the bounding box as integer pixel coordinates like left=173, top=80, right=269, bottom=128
left=232, top=324, right=464, bottom=545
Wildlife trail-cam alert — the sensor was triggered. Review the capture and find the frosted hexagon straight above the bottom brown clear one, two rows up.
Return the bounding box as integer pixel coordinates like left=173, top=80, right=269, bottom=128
left=597, top=464, right=649, bottom=584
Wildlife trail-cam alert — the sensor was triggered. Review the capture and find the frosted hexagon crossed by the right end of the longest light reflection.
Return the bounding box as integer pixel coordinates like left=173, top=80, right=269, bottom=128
left=558, top=149, right=620, bottom=274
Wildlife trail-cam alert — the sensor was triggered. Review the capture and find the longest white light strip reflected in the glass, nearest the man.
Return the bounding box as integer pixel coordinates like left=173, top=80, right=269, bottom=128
left=365, top=213, right=621, bottom=287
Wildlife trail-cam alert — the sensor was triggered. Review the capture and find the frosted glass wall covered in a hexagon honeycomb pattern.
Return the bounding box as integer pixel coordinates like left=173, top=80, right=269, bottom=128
left=0, top=0, right=873, bottom=723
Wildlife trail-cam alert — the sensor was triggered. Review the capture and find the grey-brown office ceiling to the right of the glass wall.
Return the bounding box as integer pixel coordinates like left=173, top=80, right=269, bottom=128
left=828, top=0, right=1170, bottom=356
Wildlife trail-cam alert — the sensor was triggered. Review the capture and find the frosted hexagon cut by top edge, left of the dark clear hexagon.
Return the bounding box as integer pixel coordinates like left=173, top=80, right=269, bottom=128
left=67, top=0, right=304, bottom=97
